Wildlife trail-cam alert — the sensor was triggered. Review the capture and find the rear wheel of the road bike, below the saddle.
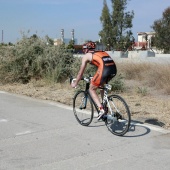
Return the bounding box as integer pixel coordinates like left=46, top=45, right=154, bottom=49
left=105, top=95, right=131, bottom=136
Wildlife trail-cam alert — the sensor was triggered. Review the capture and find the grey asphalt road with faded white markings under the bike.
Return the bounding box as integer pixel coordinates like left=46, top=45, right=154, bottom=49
left=0, top=92, right=170, bottom=170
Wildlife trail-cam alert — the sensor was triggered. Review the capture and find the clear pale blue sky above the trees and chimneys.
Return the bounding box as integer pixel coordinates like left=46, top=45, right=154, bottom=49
left=0, top=0, right=170, bottom=44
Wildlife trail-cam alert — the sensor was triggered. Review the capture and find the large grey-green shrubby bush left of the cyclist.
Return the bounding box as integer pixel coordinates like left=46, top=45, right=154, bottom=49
left=0, top=35, right=74, bottom=83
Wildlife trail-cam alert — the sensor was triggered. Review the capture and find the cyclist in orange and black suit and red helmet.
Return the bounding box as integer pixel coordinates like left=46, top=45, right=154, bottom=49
left=71, top=41, right=117, bottom=120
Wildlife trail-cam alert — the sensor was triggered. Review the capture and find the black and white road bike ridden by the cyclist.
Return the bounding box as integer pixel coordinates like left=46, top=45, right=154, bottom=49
left=70, top=76, right=131, bottom=136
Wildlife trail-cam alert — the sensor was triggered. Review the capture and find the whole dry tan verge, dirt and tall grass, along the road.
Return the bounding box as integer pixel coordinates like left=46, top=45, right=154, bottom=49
left=0, top=63, right=170, bottom=129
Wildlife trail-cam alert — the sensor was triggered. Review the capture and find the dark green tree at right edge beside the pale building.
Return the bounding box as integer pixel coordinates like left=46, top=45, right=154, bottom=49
left=151, top=7, right=170, bottom=54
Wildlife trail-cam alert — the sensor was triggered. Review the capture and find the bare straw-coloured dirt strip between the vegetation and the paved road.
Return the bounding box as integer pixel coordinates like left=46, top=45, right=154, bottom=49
left=0, top=81, right=170, bottom=129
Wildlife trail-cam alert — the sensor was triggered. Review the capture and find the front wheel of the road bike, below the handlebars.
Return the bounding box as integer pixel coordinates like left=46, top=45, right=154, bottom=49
left=73, top=91, right=94, bottom=126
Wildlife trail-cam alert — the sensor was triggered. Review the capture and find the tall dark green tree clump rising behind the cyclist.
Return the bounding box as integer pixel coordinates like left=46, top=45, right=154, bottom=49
left=99, top=0, right=134, bottom=50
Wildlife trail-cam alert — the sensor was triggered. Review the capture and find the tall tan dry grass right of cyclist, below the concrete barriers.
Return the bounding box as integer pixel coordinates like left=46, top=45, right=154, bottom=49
left=118, top=63, right=170, bottom=95
